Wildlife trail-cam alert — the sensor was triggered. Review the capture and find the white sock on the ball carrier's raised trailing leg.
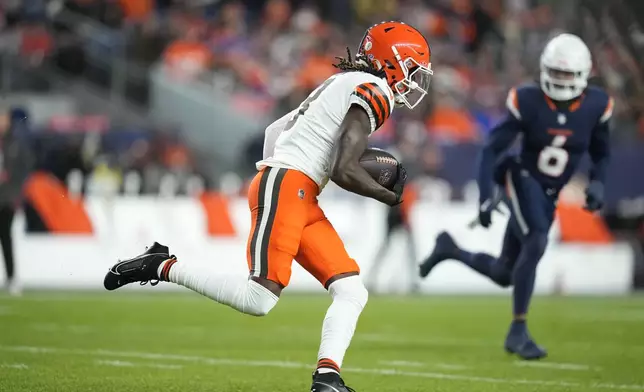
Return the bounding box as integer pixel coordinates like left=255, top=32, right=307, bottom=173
left=158, top=259, right=279, bottom=316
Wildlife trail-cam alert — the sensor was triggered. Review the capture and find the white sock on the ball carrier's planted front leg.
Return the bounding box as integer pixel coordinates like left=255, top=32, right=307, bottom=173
left=318, top=276, right=369, bottom=373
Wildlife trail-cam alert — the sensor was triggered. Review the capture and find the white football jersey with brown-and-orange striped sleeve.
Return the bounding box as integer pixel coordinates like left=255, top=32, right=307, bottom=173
left=257, top=72, right=394, bottom=190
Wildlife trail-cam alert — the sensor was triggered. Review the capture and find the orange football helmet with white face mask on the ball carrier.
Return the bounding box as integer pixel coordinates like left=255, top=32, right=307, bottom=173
left=356, top=22, right=434, bottom=109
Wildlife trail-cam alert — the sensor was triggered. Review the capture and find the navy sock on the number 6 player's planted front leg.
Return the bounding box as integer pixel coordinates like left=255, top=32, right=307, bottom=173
left=512, top=233, right=548, bottom=316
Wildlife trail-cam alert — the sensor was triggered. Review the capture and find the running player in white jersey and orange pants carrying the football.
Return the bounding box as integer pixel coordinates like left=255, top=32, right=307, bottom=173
left=104, top=22, right=432, bottom=392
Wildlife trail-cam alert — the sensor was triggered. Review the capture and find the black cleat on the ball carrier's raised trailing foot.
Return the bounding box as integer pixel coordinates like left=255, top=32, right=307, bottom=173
left=103, top=242, right=174, bottom=290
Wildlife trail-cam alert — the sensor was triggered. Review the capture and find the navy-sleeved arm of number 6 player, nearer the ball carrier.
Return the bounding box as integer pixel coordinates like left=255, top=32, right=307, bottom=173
left=477, top=89, right=521, bottom=204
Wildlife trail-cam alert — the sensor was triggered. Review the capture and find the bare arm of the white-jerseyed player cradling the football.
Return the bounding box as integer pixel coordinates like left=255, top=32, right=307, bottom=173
left=329, top=105, right=397, bottom=205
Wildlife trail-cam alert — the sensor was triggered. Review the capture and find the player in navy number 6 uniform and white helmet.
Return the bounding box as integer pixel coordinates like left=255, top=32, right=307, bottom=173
left=420, top=34, right=613, bottom=359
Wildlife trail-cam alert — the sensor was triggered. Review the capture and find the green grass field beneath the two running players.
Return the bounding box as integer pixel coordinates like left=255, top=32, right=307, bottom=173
left=0, top=290, right=644, bottom=392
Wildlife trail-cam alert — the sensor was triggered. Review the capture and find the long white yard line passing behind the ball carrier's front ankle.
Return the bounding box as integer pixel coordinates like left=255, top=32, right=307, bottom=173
left=0, top=346, right=644, bottom=391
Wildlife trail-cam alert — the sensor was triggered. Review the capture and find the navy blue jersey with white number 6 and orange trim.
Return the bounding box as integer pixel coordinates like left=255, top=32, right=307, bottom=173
left=478, top=85, right=613, bottom=201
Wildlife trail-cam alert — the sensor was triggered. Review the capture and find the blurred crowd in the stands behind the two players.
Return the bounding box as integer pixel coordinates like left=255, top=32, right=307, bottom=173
left=0, top=0, right=644, bottom=193
